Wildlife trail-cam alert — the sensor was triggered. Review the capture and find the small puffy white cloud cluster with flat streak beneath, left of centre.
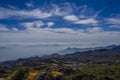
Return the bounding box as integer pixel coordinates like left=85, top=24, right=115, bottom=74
left=20, top=21, right=76, bottom=33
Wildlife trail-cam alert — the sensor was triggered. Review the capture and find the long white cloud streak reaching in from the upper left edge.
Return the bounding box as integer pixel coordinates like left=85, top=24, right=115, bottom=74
left=0, top=8, right=52, bottom=19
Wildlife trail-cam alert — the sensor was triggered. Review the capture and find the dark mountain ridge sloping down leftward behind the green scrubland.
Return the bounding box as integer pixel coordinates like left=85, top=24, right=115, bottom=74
left=0, top=45, right=120, bottom=66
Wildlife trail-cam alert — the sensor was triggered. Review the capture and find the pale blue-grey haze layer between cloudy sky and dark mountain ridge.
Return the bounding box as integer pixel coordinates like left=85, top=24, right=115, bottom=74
left=0, top=42, right=119, bottom=61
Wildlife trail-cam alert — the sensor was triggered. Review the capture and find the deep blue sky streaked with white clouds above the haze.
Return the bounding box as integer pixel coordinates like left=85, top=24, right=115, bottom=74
left=0, top=0, right=120, bottom=61
